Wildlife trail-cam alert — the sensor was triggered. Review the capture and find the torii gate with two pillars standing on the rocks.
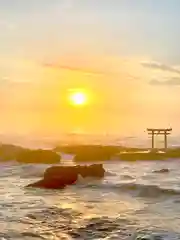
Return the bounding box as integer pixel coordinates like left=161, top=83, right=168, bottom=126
left=147, top=128, right=172, bottom=150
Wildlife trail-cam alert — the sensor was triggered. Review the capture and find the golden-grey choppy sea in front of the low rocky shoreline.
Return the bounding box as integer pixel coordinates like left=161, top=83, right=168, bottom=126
left=0, top=136, right=180, bottom=240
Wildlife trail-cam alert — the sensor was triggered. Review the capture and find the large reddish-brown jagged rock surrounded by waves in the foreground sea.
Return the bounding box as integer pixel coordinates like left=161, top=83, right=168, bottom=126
left=27, top=164, right=105, bottom=189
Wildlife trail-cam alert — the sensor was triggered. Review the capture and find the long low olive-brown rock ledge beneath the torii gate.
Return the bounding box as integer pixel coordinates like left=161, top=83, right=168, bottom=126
left=54, top=145, right=180, bottom=163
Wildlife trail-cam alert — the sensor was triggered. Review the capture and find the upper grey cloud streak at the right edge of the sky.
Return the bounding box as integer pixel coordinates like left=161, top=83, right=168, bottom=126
left=141, top=62, right=180, bottom=74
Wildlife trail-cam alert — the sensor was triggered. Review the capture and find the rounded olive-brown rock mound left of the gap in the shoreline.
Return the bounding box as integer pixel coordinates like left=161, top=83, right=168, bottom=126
left=16, top=149, right=61, bottom=164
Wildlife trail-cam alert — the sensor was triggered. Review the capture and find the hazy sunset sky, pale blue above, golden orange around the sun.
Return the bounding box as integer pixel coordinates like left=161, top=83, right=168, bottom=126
left=0, top=0, right=180, bottom=138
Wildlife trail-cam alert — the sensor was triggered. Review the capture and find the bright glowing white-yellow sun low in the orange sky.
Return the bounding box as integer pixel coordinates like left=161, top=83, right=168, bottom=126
left=69, top=90, right=88, bottom=106
